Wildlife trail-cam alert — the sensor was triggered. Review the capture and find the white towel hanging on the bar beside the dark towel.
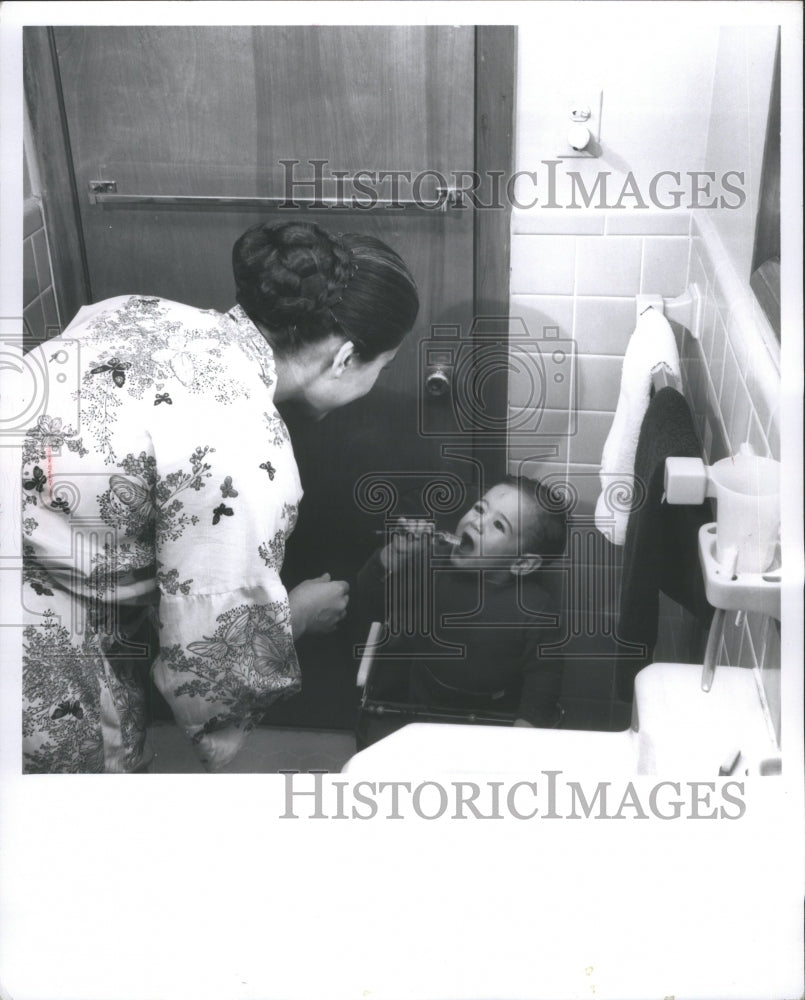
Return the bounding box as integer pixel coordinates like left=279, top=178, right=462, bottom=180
left=595, top=309, right=681, bottom=545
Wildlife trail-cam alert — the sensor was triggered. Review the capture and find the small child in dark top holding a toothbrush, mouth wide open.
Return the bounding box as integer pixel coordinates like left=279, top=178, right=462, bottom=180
left=357, top=477, right=566, bottom=744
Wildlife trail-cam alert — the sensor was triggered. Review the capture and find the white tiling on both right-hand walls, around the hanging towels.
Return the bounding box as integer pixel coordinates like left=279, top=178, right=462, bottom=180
left=509, top=210, right=780, bottom=737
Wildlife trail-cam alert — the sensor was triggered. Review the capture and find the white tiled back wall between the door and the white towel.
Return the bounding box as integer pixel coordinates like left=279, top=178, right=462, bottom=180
left=509, top=209, right=691, bottom=513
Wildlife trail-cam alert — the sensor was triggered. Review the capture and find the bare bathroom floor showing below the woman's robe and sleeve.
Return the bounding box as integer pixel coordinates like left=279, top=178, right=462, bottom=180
left=149, top=722, right=355, bottom=774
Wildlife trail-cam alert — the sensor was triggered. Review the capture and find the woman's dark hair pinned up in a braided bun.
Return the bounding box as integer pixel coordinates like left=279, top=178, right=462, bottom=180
left=232, top=222, right=419, bottom=361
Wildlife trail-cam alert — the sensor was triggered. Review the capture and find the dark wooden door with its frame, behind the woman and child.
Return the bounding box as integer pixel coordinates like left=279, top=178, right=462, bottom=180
left=27, top=26, right=513, bottom=728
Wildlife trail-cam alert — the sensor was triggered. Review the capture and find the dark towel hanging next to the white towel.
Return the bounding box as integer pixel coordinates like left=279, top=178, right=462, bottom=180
left=618, top=387, right=713, bottom=700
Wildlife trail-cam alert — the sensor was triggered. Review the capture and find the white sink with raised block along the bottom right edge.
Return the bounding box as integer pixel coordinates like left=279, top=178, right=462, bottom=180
left=343, top=663, right=780, bottom=780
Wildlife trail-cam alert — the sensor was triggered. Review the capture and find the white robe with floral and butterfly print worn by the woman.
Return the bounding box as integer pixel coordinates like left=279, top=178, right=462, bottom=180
left=22, top=296, right=302, bottom=773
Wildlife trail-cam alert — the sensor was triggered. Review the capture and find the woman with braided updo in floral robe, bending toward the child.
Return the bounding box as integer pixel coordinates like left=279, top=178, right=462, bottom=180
left=23, top=223, right=418, bottom=773
